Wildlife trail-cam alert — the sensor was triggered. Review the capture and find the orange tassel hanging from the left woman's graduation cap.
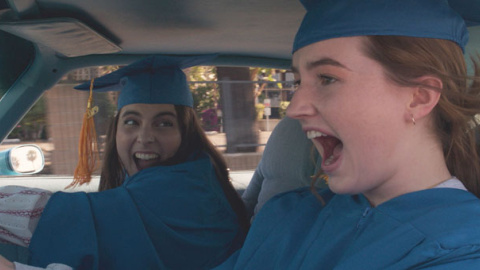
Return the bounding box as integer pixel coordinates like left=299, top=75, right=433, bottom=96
left=65, top=79, right=99, bottom=189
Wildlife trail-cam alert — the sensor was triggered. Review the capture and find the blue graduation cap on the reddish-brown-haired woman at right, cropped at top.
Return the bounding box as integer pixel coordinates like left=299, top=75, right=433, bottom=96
left=293, top=0, right=480, bottom=52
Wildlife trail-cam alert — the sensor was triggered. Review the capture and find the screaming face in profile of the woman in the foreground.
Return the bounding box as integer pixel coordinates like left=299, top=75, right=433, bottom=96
left=287, top=37, right=412, bottom=198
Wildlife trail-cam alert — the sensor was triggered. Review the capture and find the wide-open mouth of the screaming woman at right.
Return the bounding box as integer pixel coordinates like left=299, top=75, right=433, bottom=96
left=307, top=130, right=343, bottom=169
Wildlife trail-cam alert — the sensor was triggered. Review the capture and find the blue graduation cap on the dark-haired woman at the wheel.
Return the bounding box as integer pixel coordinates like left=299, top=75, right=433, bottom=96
left=75, top=55, right=216, bottom=110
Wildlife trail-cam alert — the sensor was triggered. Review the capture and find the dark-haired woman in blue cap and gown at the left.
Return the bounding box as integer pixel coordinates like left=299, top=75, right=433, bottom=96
left=0, top=54, right=249, bottom=269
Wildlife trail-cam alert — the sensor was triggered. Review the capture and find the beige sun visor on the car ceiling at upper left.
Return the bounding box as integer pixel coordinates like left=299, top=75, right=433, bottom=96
left=0, top=18, right=122, bottom=57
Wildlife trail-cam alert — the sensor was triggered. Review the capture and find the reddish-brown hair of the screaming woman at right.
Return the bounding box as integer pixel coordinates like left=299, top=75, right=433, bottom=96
left=365, top=36, right=480, bottom=197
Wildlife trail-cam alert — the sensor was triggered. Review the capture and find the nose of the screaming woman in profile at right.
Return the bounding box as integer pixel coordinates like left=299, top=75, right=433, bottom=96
left=287, top=87, right=316, bottom=119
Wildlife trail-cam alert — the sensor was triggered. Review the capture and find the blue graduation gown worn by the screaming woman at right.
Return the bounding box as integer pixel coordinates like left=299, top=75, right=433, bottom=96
left=216, top=188, right=480, bottom=270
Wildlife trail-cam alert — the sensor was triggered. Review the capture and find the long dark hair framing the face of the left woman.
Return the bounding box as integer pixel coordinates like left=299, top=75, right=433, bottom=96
left=99, top=105, right=250, bottom=231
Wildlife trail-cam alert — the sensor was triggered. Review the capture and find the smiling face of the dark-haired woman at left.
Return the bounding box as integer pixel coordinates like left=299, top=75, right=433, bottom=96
left=116, top=104, right=181, bottom=176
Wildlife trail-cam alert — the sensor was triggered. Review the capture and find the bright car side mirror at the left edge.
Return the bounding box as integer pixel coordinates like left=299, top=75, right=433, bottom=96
left=0, top=144, right=45, bottom=175
